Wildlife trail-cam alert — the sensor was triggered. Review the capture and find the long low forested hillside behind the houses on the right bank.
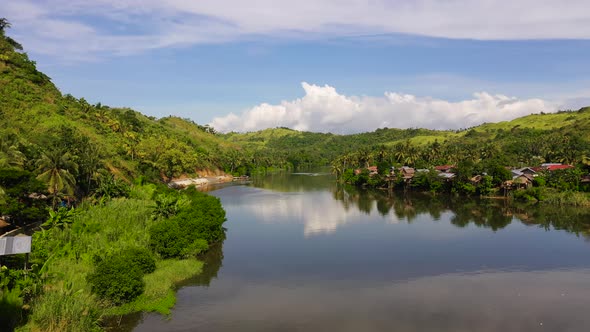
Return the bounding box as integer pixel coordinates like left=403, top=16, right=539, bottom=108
left=223, top=107, right=590, bottom=174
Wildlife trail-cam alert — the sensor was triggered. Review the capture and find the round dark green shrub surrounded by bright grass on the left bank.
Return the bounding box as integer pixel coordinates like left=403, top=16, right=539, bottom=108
left=88, top=255, right=145, bottom=304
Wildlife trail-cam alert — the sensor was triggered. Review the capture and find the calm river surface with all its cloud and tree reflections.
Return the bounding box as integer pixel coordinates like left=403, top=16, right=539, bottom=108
left=133, top=173, right=590, bottom=332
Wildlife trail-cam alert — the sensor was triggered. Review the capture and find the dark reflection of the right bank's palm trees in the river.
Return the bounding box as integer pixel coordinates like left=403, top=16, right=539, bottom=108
left=333, top=185, right=590, bottom=238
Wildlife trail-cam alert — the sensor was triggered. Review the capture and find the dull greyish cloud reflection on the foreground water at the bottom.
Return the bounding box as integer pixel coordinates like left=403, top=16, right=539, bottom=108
left=139, top=269, right=590, bottom=332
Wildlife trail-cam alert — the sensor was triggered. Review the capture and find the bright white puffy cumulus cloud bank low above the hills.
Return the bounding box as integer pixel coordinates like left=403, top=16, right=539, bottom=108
left=211, top=82, right=556, bottom=134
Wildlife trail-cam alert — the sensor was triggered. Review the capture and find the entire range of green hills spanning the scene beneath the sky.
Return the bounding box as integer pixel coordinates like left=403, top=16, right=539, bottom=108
left=0, top=17, right=590, bottom=194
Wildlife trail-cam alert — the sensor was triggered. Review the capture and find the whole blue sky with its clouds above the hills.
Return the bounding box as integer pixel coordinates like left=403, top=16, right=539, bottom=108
left=0, top=0, right=590, bottom=133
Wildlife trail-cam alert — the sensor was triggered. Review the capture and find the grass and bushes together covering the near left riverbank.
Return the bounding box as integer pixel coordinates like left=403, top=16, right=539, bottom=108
left=0, top=184, right=225, bottom=331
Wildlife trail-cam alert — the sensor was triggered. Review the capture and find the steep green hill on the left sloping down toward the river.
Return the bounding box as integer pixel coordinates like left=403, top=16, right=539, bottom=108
left=0, top=21, right=250, bottom=191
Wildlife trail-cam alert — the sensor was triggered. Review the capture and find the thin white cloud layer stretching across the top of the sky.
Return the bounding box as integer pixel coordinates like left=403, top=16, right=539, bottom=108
left=2, top=0, right=590, bottom=57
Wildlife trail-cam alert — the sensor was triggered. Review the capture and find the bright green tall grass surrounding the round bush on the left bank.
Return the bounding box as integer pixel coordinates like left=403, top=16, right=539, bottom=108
left=19, top=193, right=208, bottom=332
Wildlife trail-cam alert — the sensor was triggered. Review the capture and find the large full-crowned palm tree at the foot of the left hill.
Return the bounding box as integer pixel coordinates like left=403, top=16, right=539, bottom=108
left=37, top=150, right=78, bottom=209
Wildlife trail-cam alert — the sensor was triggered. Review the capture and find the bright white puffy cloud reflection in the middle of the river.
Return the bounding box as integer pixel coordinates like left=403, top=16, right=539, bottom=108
left=240, top=192, right=399, bottom=237
